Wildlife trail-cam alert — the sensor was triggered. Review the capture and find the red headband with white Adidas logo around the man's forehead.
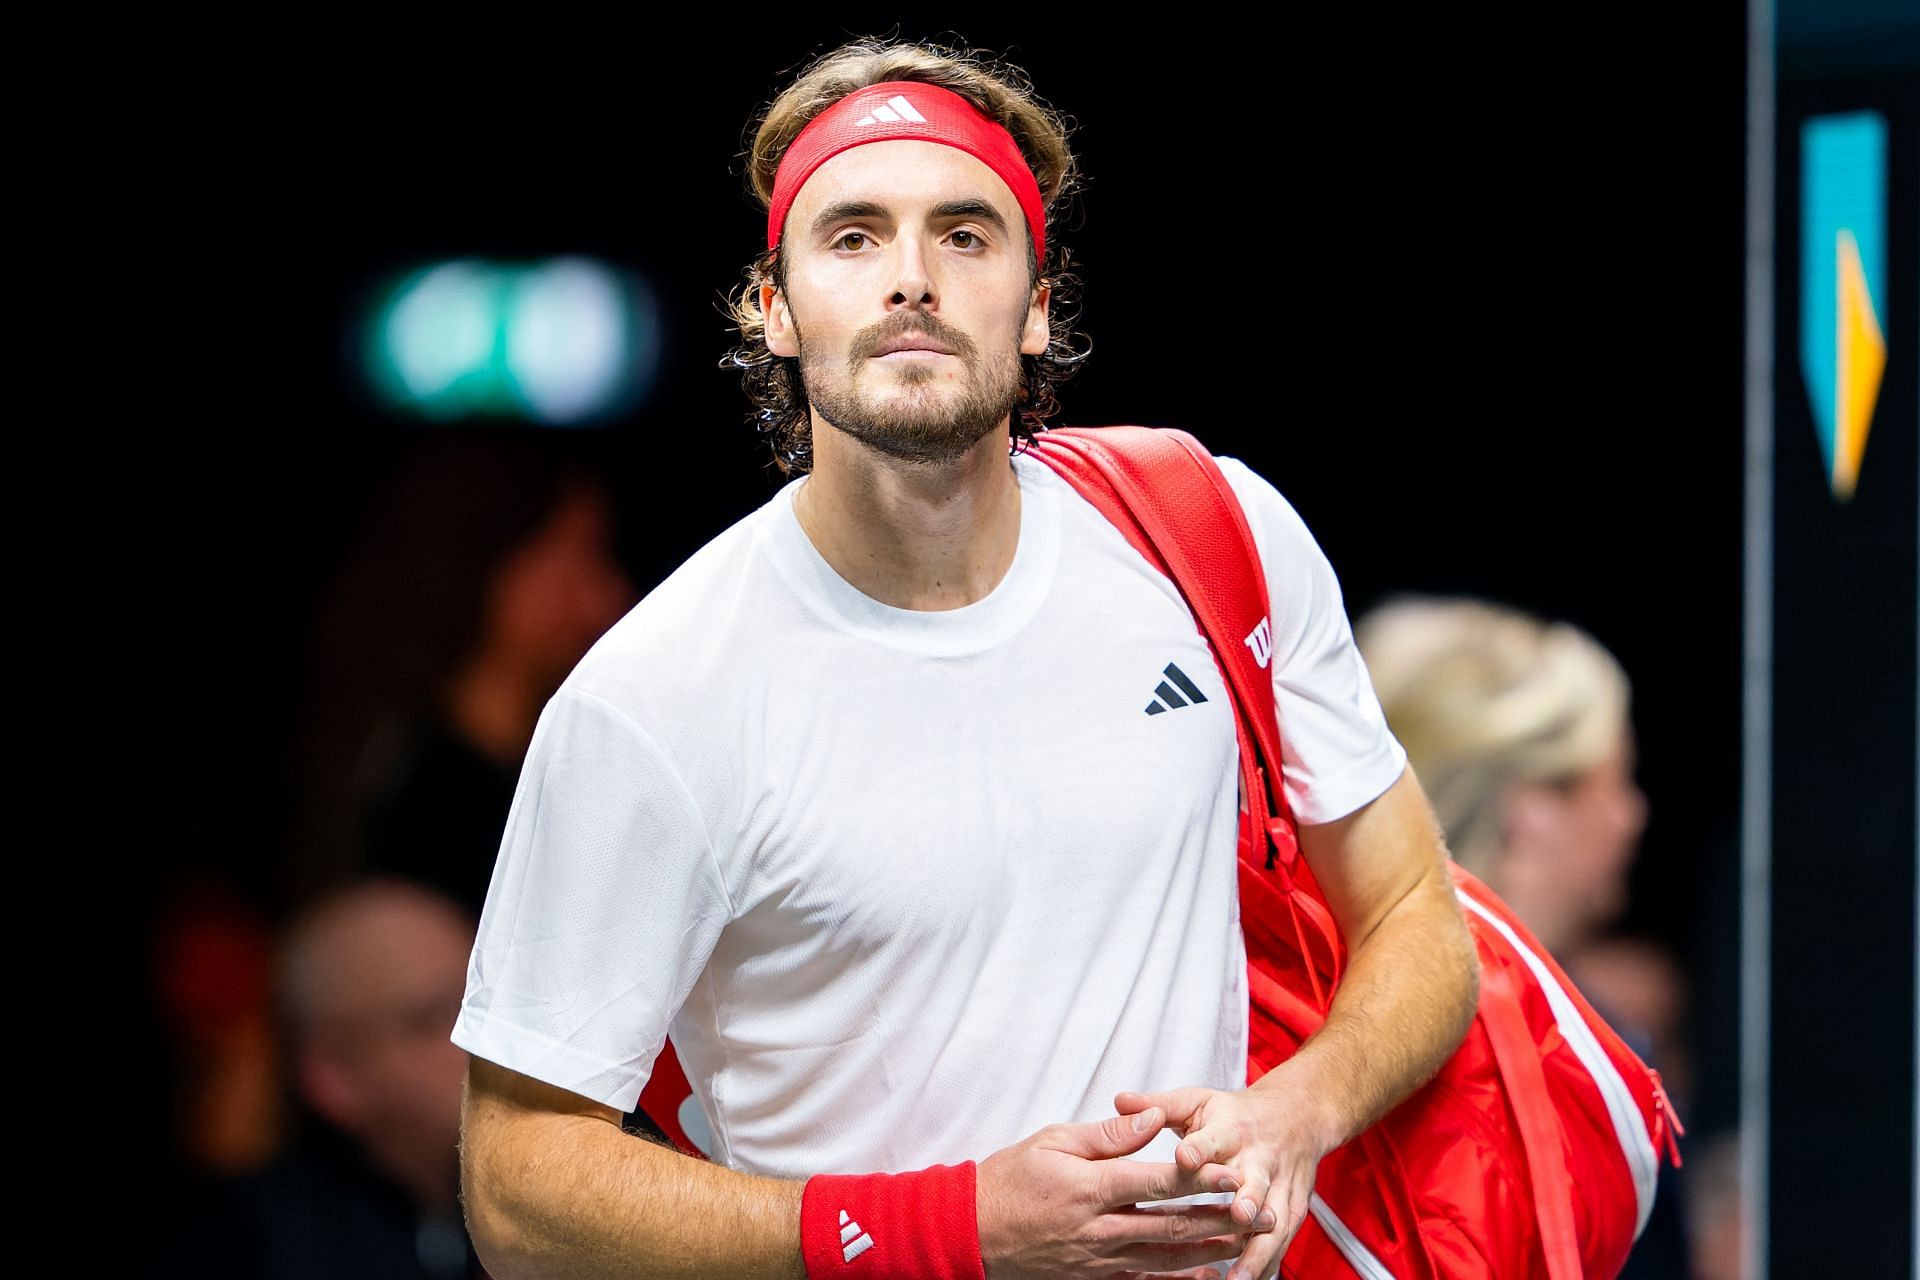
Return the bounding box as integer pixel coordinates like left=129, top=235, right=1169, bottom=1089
left=766, top=81, right=1046, bottom=265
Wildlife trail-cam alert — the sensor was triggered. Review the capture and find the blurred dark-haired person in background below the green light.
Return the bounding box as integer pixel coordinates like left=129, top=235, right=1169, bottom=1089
left=296, top=436, right=636, bottom=917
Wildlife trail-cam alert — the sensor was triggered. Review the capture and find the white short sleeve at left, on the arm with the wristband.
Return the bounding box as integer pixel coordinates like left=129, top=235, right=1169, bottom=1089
left=453, top=687, right=732, bottom=1111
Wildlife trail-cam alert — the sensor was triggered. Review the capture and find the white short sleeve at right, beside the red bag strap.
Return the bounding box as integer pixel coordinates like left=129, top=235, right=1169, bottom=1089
left=1217, top=457, right=1407, bottom=823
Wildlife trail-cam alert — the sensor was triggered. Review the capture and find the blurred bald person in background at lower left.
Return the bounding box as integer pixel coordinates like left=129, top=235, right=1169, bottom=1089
left=157, top=877, right=486, bottom=1280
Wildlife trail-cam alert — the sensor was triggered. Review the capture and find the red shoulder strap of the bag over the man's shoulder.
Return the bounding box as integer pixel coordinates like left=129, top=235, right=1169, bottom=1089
left=1031, top=426, right=1342, bottom=1009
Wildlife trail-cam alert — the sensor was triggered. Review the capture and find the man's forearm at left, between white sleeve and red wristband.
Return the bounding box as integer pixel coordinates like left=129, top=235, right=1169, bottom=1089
left=461, top=1102, right=806, bottom=1280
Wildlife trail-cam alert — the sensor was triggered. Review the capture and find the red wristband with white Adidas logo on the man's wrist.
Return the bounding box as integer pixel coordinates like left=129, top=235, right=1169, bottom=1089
left=801, top=1161, right=987, bottom=1280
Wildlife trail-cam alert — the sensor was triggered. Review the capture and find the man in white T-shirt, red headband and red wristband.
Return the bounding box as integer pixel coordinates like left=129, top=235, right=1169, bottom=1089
left=453, top=42, right=1476, bottom=1280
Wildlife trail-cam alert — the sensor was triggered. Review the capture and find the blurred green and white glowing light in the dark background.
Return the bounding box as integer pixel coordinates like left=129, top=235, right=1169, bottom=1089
left=367, top=257, right=659, bottom=426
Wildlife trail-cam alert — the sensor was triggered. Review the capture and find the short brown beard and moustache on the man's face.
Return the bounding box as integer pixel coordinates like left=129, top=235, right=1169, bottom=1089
left=793, top=311, right=1021, bottom=462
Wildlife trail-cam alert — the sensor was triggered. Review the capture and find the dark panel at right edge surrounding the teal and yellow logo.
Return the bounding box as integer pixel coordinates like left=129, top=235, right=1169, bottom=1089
left=1768, top=45, right=1920, bottom=1276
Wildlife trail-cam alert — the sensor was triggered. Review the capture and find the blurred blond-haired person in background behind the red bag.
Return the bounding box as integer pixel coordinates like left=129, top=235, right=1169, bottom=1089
left=1354, top=595, right=1690, bottom=1278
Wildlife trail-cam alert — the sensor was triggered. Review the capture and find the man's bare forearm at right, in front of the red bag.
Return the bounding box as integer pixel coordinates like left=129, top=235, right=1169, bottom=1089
left=1254, top=867, right=1480, bottom=1150
